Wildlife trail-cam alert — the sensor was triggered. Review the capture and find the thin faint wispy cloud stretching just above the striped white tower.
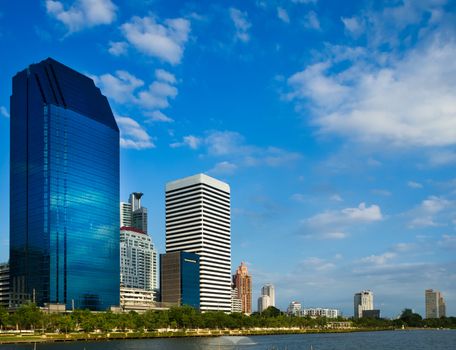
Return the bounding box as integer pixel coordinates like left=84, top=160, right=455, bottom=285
left=170, top=130, right=301, bottom=171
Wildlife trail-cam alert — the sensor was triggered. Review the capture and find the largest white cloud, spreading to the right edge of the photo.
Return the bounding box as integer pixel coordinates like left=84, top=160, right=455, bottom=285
left=286, top=1, right=456, bottom=147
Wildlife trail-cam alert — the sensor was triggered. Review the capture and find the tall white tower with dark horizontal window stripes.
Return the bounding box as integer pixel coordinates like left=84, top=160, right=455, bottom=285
left=166, top=174, right=231, bottom=312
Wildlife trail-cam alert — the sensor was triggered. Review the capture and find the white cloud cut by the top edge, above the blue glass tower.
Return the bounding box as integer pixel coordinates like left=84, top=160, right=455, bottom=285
left=46, top=0, right=117, bottom=33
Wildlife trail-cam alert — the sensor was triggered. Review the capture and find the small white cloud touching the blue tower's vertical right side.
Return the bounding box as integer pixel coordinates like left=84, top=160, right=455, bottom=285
left=116, top=116, right=155, bottom=150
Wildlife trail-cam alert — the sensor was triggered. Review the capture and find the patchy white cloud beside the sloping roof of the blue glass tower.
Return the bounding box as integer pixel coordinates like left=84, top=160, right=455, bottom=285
left=93, top=69, right=178, bottom=115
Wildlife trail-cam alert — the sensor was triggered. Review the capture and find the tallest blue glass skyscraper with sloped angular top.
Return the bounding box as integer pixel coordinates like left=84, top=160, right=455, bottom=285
left=10, top=58, right=120, bottom=310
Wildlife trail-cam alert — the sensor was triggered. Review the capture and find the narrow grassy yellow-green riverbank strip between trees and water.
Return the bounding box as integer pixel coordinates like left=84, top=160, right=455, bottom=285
left=0, top=328, right=393, bottom=344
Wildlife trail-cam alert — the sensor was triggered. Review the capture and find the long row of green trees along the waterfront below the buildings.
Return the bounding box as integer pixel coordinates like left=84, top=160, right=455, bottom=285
left=0, top=303, right=456, bottom=333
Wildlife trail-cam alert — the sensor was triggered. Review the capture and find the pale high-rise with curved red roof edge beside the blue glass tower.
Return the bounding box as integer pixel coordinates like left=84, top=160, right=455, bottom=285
left=120, top=227, right=158, bottom=291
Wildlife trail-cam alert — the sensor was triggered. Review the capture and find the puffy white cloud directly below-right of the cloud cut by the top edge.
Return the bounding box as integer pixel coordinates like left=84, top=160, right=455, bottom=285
left=121, top=16, right=191, bottom=65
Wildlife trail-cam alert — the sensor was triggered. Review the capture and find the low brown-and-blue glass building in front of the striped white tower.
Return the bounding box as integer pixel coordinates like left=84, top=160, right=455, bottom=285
left=160, top=251, right=200, bottom=309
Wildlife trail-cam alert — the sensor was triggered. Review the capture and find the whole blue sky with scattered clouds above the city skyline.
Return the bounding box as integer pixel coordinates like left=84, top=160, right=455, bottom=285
left=0, top=0, right=456, bottom=317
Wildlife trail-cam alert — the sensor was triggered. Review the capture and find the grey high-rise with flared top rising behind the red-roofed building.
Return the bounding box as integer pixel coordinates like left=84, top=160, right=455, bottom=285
left=120, top=192, right=148, bottom=233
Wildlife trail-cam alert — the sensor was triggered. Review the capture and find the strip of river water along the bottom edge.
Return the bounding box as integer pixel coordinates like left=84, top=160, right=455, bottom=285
left=0, top=330, right=456, bottom=350
